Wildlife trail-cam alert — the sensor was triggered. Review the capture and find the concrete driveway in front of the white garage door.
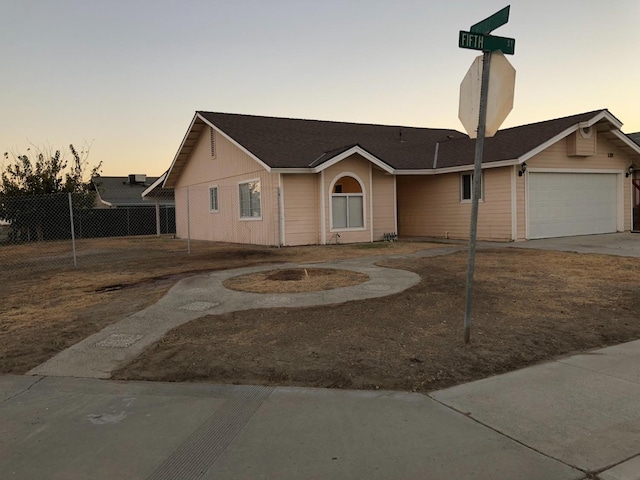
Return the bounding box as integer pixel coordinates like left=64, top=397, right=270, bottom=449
left=510, top=232, right=640, bottom=257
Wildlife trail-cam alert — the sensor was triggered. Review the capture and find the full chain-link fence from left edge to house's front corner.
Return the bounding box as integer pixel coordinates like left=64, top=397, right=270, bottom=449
left=0, top=184, right=282, bottom=280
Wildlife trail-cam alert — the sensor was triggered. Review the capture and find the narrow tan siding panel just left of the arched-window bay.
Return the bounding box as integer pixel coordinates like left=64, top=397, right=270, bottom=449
left=282, top=174, right=320, bottom=245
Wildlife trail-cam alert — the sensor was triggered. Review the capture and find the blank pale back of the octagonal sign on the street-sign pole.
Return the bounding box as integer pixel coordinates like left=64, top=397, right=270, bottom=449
left=458, top=51, right=516, bottom=138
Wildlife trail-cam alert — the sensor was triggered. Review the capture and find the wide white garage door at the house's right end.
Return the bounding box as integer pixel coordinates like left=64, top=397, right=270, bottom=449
left=529, top=172, right=618, bottom=238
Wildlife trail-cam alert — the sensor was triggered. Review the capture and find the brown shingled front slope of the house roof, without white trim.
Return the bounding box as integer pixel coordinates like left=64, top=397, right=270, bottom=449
left=197, top=110, right=602, bottom=170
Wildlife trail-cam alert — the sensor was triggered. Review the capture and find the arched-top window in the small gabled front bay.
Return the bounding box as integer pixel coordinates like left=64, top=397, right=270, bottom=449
left=331, top=177, right=364, bottom=229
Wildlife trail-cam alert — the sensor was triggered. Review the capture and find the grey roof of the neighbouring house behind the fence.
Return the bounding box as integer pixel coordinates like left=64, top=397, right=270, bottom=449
left=91, top=175, right=174, bottom=207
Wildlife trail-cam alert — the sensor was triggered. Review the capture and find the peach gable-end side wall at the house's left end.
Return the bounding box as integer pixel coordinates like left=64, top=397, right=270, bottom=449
left=175, top=129, right=280, bottom=245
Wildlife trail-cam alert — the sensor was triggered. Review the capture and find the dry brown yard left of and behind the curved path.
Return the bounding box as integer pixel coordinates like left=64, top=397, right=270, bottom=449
left=0, top=237, right=441, bottom=374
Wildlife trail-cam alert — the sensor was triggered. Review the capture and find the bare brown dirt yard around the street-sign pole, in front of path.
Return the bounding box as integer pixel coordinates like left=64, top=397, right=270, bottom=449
left=115, top=248, right=640, bottom=391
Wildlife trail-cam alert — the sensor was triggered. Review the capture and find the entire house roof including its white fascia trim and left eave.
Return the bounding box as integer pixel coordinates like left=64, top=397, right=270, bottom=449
left=164, top=109, right=640, bottom=187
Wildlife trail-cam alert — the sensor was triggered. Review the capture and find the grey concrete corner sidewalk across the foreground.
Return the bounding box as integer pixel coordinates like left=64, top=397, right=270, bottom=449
left=0, top=341, right=640, bottom=480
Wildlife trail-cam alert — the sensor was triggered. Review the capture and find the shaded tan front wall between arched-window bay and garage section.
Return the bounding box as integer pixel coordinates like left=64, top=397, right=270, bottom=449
left=397, top=167, right=511, bottom=241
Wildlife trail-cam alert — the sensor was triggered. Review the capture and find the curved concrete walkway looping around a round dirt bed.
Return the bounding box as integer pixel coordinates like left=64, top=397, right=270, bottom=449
left=28, top=247, right=462, bottom=378
